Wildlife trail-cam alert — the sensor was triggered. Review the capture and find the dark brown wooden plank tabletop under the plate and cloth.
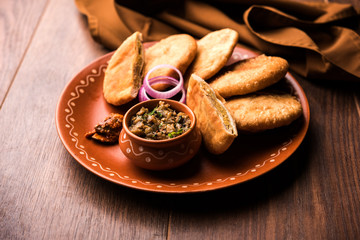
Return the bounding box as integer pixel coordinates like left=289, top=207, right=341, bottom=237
left=0, top=0, right=360, bottom=239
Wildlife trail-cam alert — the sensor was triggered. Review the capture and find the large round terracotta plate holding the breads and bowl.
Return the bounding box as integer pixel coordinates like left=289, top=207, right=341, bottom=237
left=56, top=44, right=310, bottom=193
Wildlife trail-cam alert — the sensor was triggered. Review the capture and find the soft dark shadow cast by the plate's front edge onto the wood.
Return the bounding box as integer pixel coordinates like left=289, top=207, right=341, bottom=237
left=62, top=119, right=317, bottom=223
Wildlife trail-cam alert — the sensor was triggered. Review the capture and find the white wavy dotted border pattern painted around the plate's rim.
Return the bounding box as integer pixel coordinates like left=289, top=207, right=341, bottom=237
left=64, top=53, right=292, bottom=189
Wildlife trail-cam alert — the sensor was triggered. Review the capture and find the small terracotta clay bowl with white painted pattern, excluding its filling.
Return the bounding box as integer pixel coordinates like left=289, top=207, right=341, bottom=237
left=119, top=99, right=202, bottom=170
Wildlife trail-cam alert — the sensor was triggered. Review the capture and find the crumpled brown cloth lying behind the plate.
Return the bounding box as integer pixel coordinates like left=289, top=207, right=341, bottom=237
left=75, top=0, right=360, bottom=82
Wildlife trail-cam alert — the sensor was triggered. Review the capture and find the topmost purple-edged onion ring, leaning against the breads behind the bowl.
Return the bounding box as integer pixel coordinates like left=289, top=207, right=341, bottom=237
left=143, top=64, right=184, bottom=98
